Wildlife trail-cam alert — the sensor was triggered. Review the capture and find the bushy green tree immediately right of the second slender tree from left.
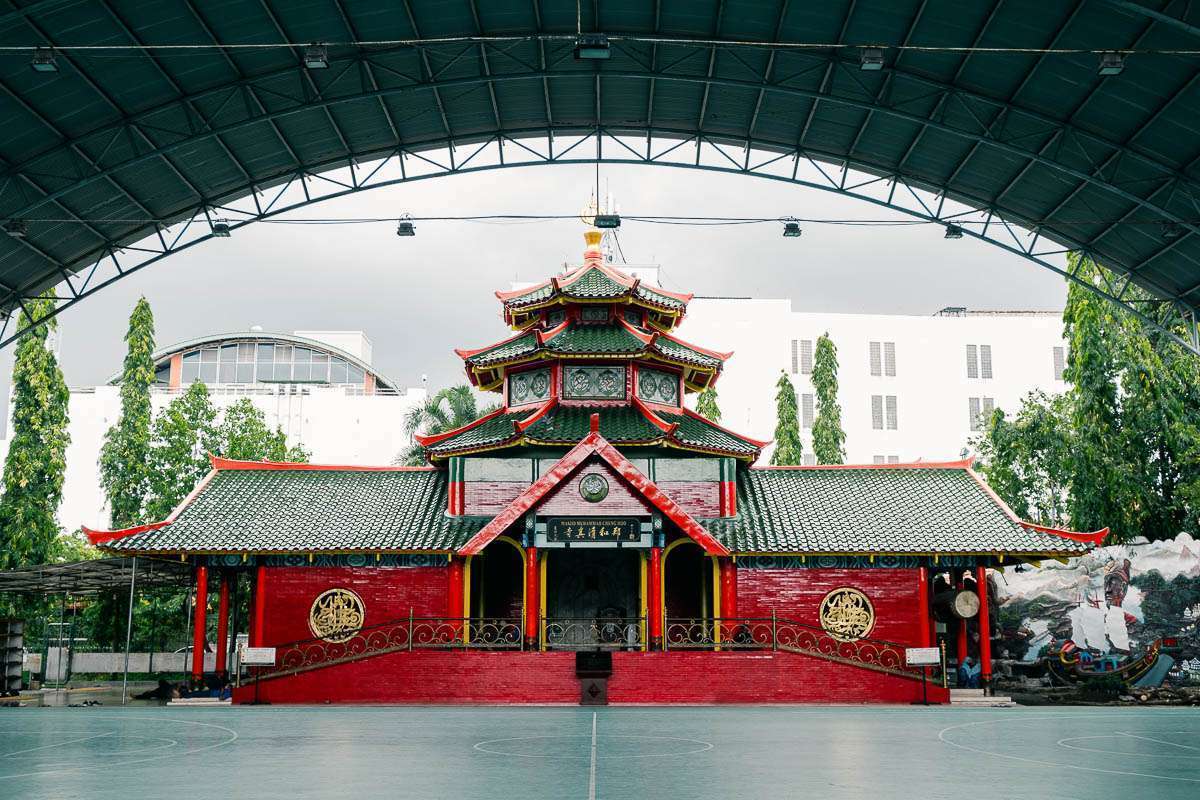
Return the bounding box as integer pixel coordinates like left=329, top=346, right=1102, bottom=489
left=145, top=381, right=221, bottom=521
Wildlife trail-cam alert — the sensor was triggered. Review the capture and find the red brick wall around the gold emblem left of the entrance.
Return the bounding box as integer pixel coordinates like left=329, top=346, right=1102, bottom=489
left=263, top=566, right=448, bottom=646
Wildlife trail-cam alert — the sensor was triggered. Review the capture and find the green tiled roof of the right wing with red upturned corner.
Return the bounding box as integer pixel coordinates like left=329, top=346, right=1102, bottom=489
left=702, top=468, right=1088, bottom=554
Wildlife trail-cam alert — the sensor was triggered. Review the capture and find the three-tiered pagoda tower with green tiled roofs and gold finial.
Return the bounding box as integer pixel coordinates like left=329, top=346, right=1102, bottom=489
left=416, top=229, right=767, bottom=464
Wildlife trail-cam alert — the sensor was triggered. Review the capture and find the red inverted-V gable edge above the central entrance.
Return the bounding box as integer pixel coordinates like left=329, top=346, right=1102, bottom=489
left=458, top=414, right=730, bottom=555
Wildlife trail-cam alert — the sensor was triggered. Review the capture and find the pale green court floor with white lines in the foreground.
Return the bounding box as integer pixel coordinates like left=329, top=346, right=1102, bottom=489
left=0, top=706, right=1200, bottom=800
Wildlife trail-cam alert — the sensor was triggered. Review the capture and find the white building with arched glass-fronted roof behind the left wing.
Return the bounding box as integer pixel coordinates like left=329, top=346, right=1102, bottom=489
left=10, top=331, right=425, bottom=530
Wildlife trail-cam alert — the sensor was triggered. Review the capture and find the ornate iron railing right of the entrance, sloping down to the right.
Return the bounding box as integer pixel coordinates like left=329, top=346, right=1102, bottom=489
left=662, top=616, right=922, bottom=679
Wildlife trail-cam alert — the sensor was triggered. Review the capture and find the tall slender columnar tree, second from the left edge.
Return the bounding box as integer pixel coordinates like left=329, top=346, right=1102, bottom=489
left=100, top=297, right=155, bottom=528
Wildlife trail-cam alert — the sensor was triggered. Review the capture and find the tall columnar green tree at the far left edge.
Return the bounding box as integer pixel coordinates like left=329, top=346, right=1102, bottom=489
left=0, top=295, right=71, bottom=569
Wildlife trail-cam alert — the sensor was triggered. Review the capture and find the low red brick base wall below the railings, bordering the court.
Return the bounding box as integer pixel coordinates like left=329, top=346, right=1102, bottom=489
left=234, top=650, right=947, bottom=704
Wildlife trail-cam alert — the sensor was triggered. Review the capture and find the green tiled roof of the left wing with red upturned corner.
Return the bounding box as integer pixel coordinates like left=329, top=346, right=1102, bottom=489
left=104, top=469, right=484, bottom=553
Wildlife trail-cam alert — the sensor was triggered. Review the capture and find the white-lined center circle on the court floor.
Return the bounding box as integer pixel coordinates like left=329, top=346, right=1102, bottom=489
left=474, top=733, right=714, bottom=760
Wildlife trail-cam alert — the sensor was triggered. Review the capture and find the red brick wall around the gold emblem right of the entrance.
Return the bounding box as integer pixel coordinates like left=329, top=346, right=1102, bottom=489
left=738, top=569, right=920, bottom=646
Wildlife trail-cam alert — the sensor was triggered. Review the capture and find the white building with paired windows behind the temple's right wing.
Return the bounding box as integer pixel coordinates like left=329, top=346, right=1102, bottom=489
left=679, top=297, right=1064, bottom=464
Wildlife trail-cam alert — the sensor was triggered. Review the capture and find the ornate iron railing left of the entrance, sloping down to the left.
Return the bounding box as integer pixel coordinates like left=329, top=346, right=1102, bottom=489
left=250, top=616, right=524, bottom=680
